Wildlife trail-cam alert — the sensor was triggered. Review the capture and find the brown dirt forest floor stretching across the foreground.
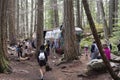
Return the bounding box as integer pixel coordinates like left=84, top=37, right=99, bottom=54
left=0, top=48, right=112, bottom=80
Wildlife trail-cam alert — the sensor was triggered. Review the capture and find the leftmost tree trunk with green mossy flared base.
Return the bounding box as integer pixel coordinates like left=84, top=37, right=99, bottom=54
left=0, top=0, right=10, bottom=73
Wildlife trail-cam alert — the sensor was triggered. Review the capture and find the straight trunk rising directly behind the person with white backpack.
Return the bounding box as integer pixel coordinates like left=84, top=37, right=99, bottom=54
left=36, top=0, right=44, bottom=52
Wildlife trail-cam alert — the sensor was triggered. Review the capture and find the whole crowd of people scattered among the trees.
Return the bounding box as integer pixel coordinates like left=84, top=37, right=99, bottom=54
left=8, top=36, right=120, bottom=80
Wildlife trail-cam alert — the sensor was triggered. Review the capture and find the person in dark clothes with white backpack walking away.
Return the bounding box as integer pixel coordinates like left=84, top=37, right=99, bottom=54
left=37, top=45, right=48, bottom=80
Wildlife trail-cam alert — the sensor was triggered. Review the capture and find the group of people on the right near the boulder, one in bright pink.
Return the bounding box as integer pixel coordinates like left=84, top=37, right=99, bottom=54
left=84, top=40, right=120, bottom=60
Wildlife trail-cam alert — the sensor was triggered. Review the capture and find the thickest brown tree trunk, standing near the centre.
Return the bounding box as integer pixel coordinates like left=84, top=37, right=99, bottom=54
left=63, top=0, right=78, bottom=61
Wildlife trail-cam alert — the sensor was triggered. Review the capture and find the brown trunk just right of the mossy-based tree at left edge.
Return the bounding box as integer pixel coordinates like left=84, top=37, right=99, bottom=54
left=8, top=0, right=16, bottom=45
